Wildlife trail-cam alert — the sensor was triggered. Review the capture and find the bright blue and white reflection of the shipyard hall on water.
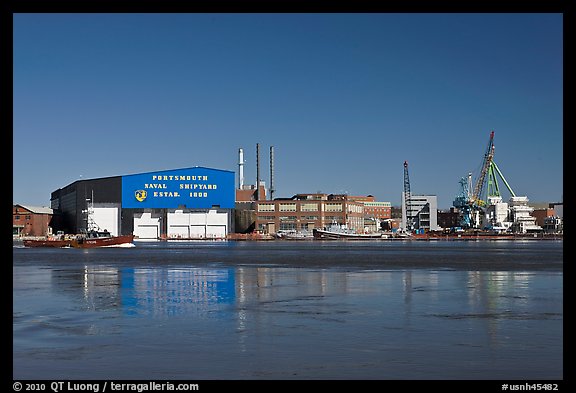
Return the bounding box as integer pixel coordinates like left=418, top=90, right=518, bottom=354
left=52, top=265, right=236, bottom=315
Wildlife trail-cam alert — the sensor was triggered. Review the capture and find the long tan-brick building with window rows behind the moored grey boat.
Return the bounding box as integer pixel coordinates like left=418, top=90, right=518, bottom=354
left=255, top=193, right=364, bottom=234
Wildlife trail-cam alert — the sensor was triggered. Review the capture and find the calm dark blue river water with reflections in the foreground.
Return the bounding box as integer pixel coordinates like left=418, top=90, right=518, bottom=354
left=13, top=241, right=563, bottom=380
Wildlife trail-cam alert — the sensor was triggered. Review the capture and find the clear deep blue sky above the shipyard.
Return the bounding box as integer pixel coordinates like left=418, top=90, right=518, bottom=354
left=13, top=13, right=563, bottom=208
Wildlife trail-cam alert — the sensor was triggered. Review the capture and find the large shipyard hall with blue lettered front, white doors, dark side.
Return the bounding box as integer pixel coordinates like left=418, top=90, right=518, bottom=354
left=50, top=167, right=234, bottom=239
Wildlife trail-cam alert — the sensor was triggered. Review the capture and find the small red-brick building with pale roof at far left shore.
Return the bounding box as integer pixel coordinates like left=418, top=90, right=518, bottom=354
left=12, top=204, right=56, bottom=236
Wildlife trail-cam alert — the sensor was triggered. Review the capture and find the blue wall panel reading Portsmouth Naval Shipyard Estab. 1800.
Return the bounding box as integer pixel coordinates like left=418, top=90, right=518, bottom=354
left=122, top=167, right=235, bottom=209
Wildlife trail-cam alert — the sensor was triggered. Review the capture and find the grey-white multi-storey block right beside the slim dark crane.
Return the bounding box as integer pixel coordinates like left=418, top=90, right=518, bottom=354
left=400, top=192, right=441, bottom=231
